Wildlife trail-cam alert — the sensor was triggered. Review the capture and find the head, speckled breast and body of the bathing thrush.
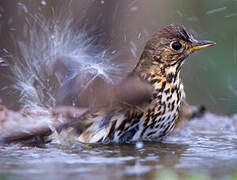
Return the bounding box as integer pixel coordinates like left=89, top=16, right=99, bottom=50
left=74, top=24, right=216, bottom=143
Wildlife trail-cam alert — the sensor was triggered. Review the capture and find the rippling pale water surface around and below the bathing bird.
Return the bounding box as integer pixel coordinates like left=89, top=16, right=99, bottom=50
left=0, top=113, right=237, bottom=179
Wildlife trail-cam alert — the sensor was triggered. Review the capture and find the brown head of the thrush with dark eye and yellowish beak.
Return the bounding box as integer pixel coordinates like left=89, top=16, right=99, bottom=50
left=137, top=24, right=216, bottom=74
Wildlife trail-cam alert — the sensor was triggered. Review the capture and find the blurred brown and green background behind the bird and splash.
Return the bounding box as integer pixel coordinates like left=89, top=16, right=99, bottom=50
left=0, top=0, right=237, bottom=114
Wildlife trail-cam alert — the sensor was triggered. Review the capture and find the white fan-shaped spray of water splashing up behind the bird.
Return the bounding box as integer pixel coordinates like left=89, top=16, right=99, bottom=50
left=10, top=12, right=118, bottom=108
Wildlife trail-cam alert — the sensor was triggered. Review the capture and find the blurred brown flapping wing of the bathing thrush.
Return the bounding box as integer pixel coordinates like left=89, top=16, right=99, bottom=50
left=54, top=57, right=152, bottom=110
